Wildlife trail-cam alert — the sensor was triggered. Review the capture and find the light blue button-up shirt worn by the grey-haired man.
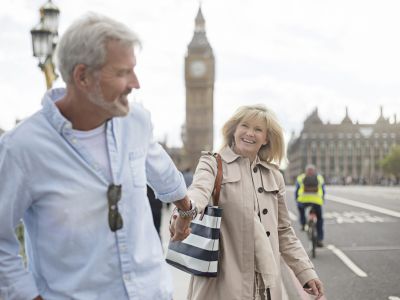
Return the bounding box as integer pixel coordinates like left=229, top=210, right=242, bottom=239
left=0, top=89, right=186, bottom=300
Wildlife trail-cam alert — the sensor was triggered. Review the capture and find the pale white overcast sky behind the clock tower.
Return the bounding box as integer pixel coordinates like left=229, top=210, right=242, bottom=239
left=0, top=0, right=400, bottom=148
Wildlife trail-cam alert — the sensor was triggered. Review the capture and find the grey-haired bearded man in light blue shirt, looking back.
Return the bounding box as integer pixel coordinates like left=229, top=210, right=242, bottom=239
left=0, top=14, right=196, bottom=300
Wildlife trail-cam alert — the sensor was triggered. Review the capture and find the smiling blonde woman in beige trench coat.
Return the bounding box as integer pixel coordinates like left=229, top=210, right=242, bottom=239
left=181, top=105, right=323, bottom=300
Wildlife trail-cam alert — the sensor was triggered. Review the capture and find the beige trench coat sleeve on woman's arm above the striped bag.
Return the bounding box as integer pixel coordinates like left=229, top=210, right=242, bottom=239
left=188, top=154, right=217, bottom=211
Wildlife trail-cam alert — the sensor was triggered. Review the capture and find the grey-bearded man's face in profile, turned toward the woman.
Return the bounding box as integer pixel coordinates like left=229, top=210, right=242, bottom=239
left=88, top=41, right=140, bottom=117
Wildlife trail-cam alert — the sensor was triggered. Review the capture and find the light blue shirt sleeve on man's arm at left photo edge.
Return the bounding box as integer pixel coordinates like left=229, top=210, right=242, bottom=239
left=0, top=137, right=39, bottom=300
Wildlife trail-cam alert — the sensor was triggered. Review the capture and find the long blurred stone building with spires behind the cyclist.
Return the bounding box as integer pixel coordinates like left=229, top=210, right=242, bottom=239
left=285, top=107, right=400, bottom=184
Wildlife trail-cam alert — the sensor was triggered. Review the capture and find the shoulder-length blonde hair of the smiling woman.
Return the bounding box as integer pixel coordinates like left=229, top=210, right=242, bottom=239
left=221, top=104, right=285, bottom=164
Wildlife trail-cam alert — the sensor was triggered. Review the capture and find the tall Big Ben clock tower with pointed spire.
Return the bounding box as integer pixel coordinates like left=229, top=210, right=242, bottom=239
left=183, top=7, right=215, bottom=171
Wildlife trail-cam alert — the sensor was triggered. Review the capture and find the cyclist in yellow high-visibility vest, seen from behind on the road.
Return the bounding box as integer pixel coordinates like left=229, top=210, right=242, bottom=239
left=295, top=165, right=325, bottom=247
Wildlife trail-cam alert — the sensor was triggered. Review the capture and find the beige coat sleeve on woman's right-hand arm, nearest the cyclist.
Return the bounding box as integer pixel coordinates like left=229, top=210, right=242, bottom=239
left=275, top=171, right=318, bottom=286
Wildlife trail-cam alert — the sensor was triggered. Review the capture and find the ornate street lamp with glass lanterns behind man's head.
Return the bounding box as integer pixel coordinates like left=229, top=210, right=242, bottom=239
left=31, top=0, right=60, bottom=89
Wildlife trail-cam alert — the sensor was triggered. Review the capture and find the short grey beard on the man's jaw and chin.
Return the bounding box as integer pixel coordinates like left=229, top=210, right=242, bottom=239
left=88, top=82, right=131, bottom=117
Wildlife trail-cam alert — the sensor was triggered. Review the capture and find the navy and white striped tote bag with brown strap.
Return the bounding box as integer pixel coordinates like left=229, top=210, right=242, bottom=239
left=166, top=153, right=222, bottom=277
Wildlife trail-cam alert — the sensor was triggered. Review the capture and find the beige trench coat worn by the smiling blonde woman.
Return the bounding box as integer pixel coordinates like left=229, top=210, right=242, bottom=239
left=187, top=147, right=317, bottom=300
